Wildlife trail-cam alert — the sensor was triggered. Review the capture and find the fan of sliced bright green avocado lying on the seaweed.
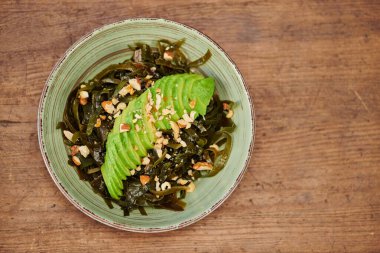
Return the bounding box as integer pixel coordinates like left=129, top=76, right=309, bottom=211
left=101, top=74, right=215, bottom=199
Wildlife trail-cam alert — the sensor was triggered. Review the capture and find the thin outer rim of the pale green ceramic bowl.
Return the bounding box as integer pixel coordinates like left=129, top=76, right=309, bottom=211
left=37, top=18, right=256, bottom=233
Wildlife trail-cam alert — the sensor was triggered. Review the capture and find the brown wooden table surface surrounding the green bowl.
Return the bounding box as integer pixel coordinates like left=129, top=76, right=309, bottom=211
left=0, top=0, right=380, bottom=252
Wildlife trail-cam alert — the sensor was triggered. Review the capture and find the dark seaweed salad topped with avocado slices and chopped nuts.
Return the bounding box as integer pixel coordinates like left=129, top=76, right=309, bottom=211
left=57, top=39, right=234, bottom=215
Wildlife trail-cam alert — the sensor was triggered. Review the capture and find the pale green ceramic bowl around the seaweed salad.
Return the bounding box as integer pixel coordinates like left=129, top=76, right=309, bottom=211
left=38, top=19, right=254, bottom=232
